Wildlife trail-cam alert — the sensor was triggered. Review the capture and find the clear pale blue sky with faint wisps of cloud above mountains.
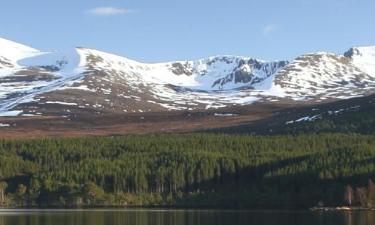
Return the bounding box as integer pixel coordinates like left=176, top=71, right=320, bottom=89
left=0, top=0, right=375, bottom=62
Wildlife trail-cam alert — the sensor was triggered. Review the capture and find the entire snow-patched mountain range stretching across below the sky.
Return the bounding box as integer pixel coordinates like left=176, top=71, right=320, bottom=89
left=0, top=39, right=375, bottom=116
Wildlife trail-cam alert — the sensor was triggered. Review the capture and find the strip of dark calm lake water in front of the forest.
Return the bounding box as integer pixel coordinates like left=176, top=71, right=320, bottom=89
left=0, top=209, right=375, bottom=225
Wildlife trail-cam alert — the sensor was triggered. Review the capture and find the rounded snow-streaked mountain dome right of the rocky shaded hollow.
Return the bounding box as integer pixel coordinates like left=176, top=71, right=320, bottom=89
left=274, top=52, right=375, bottom=101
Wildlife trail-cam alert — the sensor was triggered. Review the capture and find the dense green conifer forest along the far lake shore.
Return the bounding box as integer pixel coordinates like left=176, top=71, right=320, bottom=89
left=0, top=134, right=375, bottom=208
